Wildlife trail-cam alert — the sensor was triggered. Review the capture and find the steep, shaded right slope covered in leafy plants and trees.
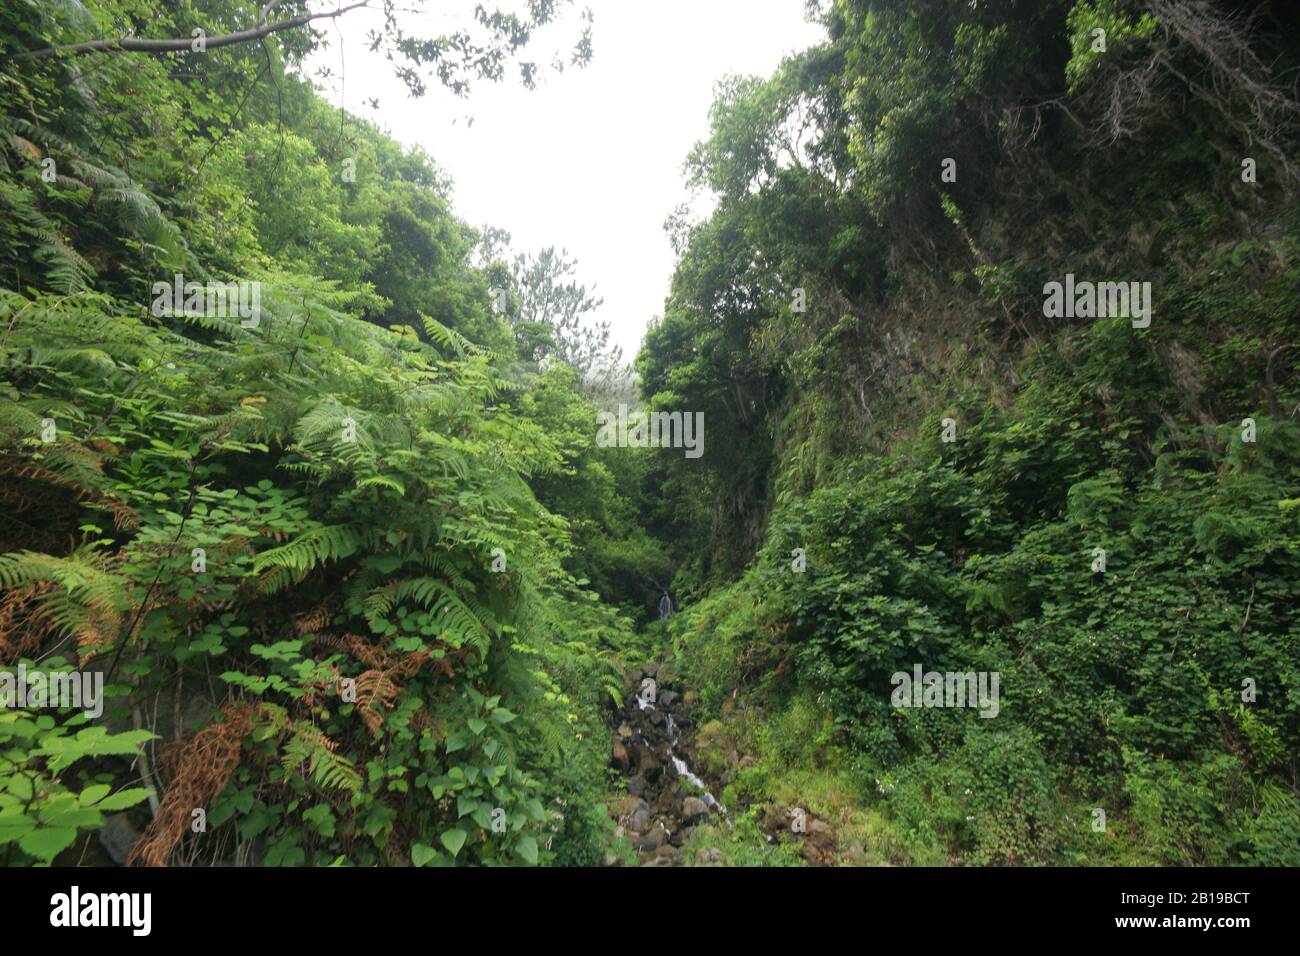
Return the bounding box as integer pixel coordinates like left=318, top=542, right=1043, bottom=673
left=638, top=0, right=1300, bottom=865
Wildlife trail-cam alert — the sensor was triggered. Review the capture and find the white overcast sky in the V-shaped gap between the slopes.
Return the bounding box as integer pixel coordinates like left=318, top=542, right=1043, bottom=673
left=311, top=0, right=823, bottom=360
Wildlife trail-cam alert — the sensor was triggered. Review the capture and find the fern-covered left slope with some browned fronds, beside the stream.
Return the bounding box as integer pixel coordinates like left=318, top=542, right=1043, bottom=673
left=0, top=1, right=627, bottom=865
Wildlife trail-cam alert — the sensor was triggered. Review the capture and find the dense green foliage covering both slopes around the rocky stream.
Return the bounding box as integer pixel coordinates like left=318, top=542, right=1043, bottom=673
left=0, top=0, right=1300, bottom=866
